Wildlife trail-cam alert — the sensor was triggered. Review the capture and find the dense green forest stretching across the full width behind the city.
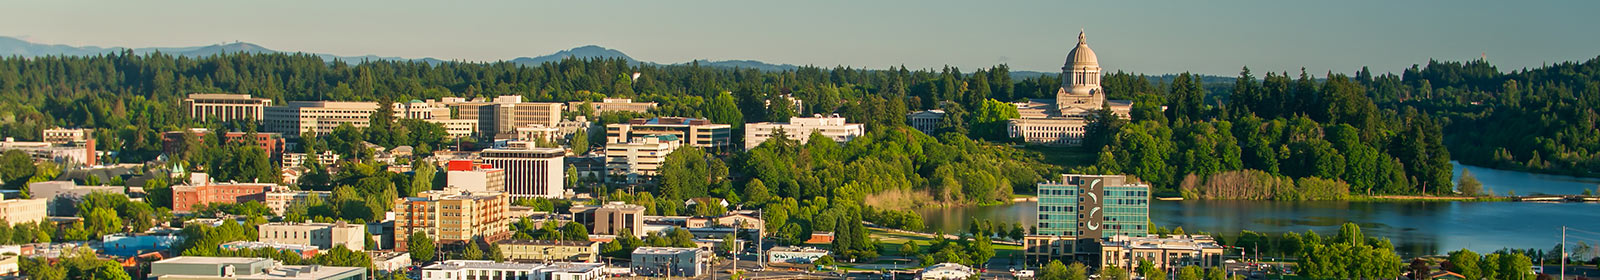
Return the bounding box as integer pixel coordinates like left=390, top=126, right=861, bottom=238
left=0, top=53, right=1600, bottom=203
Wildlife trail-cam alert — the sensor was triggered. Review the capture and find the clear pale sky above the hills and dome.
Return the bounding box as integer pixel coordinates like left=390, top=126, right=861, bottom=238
left=0, top=0, right=1600, bottom=77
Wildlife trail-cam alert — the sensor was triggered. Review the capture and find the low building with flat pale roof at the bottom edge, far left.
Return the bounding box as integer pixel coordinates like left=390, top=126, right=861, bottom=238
left=149, top=256, right=366, bottom=280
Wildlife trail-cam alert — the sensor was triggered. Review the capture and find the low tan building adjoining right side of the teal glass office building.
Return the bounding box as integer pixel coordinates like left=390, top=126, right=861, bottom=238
left=1099, top=235, right=1224, bottom=270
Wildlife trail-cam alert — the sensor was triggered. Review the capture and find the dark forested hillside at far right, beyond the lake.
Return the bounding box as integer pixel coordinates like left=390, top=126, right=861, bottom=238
left=1362, top=59, right=1600, bottom=176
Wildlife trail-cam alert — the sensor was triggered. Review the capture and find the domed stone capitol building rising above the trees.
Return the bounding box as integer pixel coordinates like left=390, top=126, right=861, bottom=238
left=1006, top=32, right=1133, bottom=146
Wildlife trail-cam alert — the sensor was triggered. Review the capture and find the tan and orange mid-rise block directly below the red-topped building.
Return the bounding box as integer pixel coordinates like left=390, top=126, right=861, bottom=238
left=394, top=189, right=510, bottom=251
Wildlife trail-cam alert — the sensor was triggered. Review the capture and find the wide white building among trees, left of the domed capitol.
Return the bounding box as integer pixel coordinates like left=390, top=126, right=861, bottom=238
left=744, top=114, right=867, bottom=150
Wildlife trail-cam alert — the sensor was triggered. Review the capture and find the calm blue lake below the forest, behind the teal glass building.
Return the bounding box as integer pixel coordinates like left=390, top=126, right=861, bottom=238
left=918, top=165, right=1600, bottom=256
